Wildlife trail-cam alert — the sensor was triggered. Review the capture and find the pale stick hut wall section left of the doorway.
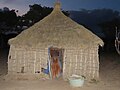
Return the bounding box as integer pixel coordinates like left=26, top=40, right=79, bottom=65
left=8, top=46, right=48, bottom=74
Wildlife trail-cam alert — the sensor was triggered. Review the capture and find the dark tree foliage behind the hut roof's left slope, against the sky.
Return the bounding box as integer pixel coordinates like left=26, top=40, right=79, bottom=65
left=0, top=4, right=69, bottom=32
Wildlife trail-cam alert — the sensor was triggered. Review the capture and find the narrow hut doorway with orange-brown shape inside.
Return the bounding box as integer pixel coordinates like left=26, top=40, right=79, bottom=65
left=48, top=47, right=64, bottom=79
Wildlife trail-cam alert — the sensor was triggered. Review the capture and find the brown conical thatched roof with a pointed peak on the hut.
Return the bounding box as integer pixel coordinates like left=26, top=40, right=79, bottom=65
left=9, top=2, right=103, bottom=48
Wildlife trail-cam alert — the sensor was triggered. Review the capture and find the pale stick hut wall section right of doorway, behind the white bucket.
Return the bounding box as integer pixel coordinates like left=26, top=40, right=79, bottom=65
left=63, top=47, right=99, bottom=79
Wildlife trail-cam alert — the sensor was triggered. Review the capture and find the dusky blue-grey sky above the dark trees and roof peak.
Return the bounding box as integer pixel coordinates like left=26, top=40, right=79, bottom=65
left=0, top=0, right=120, bottom=15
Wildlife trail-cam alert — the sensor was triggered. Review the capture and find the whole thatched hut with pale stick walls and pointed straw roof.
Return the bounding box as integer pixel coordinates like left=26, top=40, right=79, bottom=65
left=8, top=2, right=103, bottom=79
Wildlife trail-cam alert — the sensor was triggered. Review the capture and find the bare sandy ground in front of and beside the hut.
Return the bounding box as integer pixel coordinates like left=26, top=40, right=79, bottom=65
left=0, top=51, right=120, bottom=90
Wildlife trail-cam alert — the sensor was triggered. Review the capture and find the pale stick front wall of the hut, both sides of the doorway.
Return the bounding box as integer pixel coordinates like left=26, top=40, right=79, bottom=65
left=8, top=46, right=99, bottom=79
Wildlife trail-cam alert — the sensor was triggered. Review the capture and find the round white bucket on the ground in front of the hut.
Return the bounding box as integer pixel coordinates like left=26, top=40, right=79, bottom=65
left=69, top=75, right=85, bottom=87
